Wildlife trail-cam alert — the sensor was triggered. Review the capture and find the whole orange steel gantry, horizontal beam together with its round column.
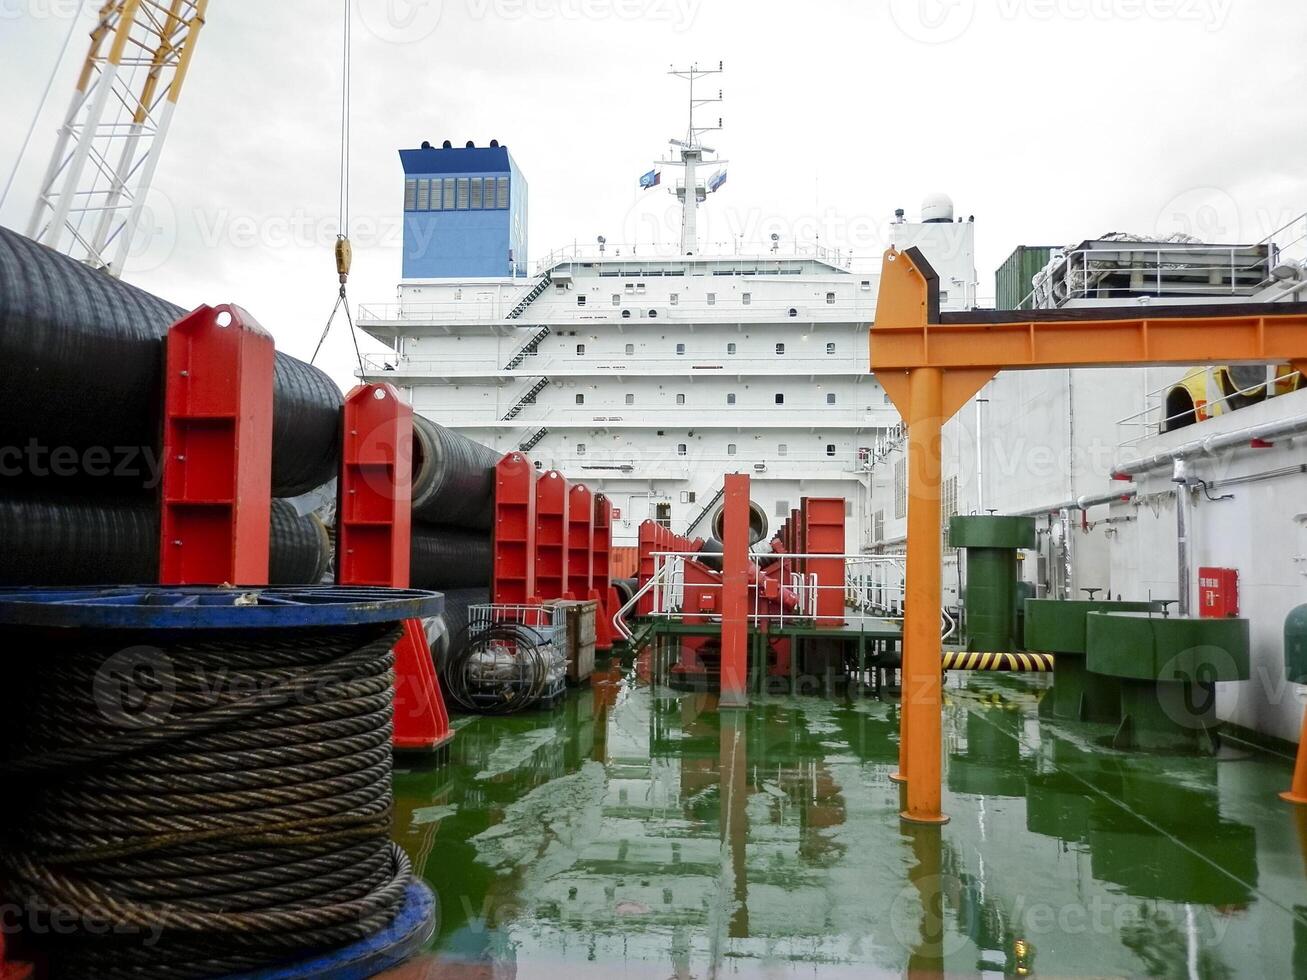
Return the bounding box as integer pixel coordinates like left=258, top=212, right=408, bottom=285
left=869, top=248, right=1307, bottom=823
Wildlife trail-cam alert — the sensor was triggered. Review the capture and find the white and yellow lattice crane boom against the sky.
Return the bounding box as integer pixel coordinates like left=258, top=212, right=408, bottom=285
left=27, top=0, right=208, bottom=276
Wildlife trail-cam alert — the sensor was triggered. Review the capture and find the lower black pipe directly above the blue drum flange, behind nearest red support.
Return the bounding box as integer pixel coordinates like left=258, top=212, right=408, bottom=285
left=0, top=497, right=331, bottom=585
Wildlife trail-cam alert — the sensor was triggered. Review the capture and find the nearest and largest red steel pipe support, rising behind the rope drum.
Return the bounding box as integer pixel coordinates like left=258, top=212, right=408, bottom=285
left=159, top=306, right=276, bottom=585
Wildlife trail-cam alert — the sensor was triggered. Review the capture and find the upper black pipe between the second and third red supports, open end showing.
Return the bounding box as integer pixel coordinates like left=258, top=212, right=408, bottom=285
left=413, top=416, right=503, bottom=531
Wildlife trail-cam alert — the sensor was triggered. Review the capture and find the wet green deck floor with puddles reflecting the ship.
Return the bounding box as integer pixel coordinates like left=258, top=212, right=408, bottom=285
left=384, top=669, right=1307, bottom=980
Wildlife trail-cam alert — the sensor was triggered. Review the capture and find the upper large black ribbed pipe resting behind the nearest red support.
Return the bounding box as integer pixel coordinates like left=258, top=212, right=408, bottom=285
left=0, top=227, right=342, bottom=497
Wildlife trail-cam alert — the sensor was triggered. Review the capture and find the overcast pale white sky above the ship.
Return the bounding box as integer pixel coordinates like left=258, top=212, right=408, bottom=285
left=0, top=0, right=1307, bottom=385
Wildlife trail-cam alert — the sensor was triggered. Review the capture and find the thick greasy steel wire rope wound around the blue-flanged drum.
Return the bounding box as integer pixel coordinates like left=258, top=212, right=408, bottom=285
left=0, top=625, right=410, bottom=980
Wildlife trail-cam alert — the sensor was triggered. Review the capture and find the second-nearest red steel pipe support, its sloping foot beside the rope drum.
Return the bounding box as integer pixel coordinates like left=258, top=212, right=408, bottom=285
left=336, top=384, right=454, bottom=750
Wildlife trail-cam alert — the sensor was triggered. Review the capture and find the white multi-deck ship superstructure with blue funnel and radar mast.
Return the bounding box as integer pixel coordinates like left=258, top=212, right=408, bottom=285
left=359, top=85, right=976, bottom=551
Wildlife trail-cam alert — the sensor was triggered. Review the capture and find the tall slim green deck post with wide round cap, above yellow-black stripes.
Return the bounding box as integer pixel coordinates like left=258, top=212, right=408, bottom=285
left=949, top=516, right=1035, bottom=653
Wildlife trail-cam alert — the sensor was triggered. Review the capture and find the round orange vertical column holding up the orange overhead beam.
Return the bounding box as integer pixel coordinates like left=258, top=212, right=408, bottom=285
left=899, top=367, right=948, bottom=823
